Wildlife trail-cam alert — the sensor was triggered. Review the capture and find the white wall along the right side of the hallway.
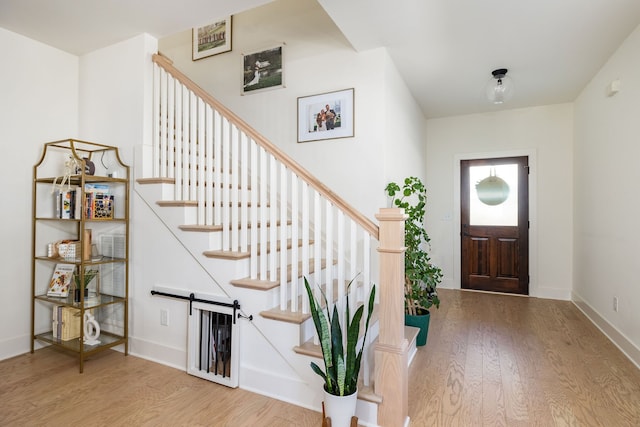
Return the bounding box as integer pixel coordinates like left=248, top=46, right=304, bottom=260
left=574, top=22, right=640, bottom=365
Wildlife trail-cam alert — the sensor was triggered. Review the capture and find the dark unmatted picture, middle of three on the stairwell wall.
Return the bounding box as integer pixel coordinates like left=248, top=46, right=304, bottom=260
left=242, top=46, right=284, bottom=95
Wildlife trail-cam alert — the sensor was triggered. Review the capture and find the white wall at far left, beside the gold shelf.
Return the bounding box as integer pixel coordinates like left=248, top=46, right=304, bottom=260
left=0, top=28, right=78, bottom=359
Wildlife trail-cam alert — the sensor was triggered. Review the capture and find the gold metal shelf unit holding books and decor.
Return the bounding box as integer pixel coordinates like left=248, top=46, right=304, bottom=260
left=31, top=139, right=130, bottom=372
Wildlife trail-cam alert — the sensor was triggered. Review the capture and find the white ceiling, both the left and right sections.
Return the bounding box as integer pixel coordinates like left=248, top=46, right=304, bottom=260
left=0, top=0, right=640, bottom=118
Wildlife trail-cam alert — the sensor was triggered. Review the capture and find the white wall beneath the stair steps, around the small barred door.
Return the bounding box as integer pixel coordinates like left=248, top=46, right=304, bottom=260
left=131, top=184, right=350, bottom=418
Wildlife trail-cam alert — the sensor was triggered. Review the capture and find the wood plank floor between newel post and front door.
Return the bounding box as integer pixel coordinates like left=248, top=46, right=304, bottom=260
left=409, top=289, right=640, bottom=427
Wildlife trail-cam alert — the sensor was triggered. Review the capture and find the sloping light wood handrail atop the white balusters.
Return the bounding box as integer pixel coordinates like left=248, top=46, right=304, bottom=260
left=152, top=54, right=379, bottom=240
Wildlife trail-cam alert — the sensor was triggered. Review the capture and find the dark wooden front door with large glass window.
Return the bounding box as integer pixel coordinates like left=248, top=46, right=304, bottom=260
left=460, top=156, right=529, bottom=295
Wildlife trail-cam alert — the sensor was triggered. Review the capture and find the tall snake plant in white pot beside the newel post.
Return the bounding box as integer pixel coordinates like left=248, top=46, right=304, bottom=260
left=304, top=277, right=376, bottom=427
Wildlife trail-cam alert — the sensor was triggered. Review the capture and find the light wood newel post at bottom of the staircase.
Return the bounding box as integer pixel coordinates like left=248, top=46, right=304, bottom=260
left=375, top=208, right=409, bottom=427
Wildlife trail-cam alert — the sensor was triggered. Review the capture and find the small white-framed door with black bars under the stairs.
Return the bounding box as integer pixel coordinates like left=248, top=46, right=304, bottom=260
left=187, top=302, right=240, bottom=387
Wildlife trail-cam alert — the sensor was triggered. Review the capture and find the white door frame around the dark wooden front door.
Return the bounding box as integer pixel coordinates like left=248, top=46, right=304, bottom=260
left=453, top=149, right=539, bottom=297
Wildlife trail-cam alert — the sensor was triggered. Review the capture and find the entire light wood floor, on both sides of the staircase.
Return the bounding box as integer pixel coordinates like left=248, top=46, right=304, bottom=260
left=0, top=289, right=640, bottom=427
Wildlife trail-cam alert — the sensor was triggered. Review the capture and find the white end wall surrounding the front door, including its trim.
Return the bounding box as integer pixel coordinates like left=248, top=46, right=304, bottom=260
left=426, top=104, right=573, bottom=299
